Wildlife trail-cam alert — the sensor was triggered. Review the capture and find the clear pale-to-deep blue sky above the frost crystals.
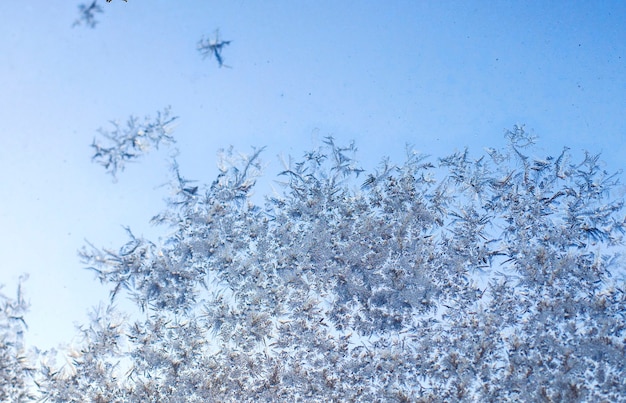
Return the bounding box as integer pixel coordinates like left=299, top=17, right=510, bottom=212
left=0, top=0, right=626, bottom=348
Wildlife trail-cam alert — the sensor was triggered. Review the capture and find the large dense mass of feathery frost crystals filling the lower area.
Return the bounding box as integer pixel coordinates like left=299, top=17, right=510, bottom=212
left=3, top=127, right=626, bottom=402
